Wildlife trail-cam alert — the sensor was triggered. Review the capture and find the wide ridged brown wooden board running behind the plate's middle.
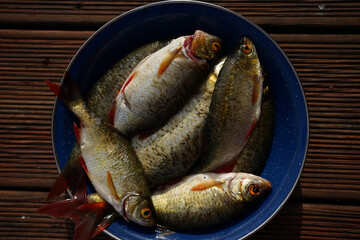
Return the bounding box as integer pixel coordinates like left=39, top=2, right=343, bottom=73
left=0, top=30, right=360, bottom=199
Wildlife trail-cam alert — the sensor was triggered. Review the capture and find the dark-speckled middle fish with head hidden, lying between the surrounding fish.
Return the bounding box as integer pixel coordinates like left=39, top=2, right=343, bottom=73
left=130, top=58, right=225, bottom=187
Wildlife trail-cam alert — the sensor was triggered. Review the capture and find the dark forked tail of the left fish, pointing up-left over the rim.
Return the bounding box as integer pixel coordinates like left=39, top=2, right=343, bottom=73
left=45, top=71, right=85, bottom=119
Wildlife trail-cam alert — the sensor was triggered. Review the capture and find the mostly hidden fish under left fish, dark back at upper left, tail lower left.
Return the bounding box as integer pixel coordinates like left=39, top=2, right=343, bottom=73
left=46, top=40, right=169, bottom=201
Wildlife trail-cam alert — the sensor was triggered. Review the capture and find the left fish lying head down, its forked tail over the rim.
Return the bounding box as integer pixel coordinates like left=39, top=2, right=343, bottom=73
left=46, top=72, right=156, bottom=226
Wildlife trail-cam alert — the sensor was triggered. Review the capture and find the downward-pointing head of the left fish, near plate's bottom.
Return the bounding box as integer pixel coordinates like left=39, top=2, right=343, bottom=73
left=123, top=195, right=156, bottom=227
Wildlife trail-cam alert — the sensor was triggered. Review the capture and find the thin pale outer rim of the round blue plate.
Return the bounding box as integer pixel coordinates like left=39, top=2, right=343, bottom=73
left=51, top=0, right=309, bottom=240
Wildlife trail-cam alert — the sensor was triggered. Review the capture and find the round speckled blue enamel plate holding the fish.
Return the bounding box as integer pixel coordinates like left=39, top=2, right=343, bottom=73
left=52, top=1, right=309, bottom=240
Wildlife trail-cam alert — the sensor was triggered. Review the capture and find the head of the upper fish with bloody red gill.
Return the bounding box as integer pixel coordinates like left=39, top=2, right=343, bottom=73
left=184, top=30, right=222, bottom=61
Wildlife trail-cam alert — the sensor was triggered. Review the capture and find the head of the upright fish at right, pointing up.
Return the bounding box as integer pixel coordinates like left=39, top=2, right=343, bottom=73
left=233, top=37, right=260, bottom=72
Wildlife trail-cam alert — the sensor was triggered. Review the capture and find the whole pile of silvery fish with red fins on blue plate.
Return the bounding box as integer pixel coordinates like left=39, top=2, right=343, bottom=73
left=37, top=30, right=274, bottom=239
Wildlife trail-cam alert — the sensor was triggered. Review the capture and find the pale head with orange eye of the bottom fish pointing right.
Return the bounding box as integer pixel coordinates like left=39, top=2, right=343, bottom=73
left=230, top=173, right=272, bottom=202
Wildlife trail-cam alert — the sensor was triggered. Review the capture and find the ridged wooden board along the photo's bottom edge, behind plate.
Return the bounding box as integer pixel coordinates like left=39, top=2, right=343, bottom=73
left=0, top=191, right=360, bottom=240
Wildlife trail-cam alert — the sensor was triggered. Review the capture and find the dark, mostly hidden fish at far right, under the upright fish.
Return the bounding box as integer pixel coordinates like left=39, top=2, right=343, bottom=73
left=233, top=81, right=275, bottom=175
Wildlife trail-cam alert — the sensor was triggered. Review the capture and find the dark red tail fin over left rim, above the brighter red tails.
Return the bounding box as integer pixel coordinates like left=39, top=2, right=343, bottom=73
left=46, top=143, right=85, bottom=201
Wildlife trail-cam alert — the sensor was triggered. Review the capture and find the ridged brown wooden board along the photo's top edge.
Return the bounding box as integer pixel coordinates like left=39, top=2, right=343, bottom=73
left=0, top=0, right=360, bottom=27
